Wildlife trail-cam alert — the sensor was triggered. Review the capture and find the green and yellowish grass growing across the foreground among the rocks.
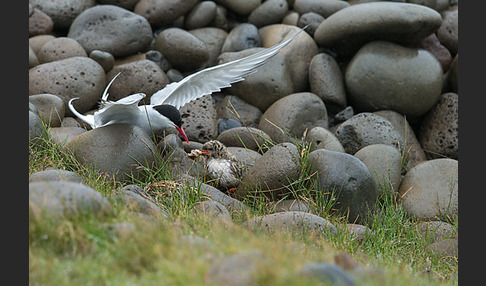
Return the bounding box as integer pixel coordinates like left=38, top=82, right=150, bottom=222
left=29, top=127, right=458, bottom=285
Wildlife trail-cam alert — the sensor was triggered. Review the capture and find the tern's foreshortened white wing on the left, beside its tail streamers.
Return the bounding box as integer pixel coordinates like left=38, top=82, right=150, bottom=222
left=94, top=93, right=145, bottom=127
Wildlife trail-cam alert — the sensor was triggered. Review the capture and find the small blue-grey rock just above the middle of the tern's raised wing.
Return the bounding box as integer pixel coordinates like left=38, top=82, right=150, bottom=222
left=221, top=23, right=262, bottom=53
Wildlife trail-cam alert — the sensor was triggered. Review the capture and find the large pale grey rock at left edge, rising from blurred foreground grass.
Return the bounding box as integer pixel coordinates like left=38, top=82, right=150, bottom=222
left=29, top=181, right=111, bottom=219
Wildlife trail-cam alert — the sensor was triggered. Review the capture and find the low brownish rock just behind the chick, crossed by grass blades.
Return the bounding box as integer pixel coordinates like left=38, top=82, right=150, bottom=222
left=216, top=127, right=272, bottom=153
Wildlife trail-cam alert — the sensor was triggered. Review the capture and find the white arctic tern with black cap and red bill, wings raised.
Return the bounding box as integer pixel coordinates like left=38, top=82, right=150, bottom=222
left=68, top=28, right=305, bottom=143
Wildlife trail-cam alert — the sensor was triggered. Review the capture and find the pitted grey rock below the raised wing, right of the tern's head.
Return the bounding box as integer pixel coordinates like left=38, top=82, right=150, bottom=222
left=179, top=95, right=218, bottom=143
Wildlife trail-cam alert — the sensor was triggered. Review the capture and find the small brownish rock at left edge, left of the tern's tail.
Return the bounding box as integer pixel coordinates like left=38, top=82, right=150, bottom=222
left=29, top=94, right=65, bottom=127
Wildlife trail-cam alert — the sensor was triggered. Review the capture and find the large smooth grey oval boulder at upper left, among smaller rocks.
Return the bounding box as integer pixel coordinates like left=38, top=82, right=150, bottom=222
left=68, top=5, right=152, bottom=57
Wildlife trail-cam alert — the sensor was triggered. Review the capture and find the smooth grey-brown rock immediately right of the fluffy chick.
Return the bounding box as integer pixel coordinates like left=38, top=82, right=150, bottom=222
left=234, top=143, right=300, bottom=200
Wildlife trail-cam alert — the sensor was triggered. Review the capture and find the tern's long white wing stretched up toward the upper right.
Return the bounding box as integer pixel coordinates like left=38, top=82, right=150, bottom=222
left=150, top=30, right=302, bottom=108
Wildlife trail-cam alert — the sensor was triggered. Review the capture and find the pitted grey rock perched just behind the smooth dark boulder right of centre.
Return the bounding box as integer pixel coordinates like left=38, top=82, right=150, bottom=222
left=334, top=112, right=405, bottom=154
